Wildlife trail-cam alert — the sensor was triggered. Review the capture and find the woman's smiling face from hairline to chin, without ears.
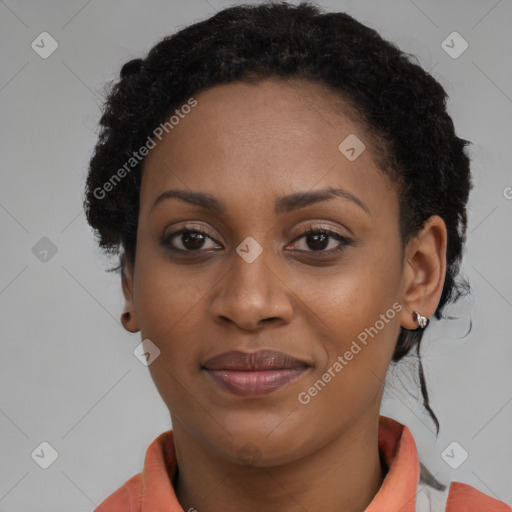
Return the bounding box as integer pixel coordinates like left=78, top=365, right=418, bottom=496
left=121, top=80, right=442, bottom=465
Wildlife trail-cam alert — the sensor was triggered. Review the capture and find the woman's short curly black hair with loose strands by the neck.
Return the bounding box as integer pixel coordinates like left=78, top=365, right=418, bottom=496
left=84, top=2, right=473, bottom=433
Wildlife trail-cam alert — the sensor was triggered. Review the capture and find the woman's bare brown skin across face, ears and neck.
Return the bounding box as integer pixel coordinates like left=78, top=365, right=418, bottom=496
left=122, top=79, right=447, bottom=512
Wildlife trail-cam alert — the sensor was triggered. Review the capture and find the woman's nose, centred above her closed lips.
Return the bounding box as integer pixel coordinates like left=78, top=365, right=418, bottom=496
left=211, top=250, right=293, bottom=331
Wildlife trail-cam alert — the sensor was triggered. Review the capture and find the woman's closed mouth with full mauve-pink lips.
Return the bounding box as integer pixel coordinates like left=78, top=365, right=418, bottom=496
left=201, top=350, right=312, bottom=397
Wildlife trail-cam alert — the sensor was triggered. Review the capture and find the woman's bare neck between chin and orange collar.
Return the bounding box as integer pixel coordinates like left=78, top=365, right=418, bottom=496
left=173, top=417, right=386, bottom=512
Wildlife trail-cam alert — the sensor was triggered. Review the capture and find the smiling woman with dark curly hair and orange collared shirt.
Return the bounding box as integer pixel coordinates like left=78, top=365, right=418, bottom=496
left=85, top=3, right=512, bottom=512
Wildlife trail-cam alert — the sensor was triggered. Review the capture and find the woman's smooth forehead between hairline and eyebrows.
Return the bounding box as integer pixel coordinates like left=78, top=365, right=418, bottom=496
left=141, top=79, right=393, bottom=217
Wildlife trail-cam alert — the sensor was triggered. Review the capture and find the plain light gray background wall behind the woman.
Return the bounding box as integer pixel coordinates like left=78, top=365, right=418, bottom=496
left=0, top=0, right=512, bottom=512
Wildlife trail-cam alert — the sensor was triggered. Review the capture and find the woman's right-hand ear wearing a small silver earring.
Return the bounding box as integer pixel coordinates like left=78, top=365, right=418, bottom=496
left=400, top=215, right=447, bottom=330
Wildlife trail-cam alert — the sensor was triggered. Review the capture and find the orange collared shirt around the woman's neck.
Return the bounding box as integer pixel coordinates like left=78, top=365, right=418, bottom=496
left=94, top=416, right=512, bottom=512
